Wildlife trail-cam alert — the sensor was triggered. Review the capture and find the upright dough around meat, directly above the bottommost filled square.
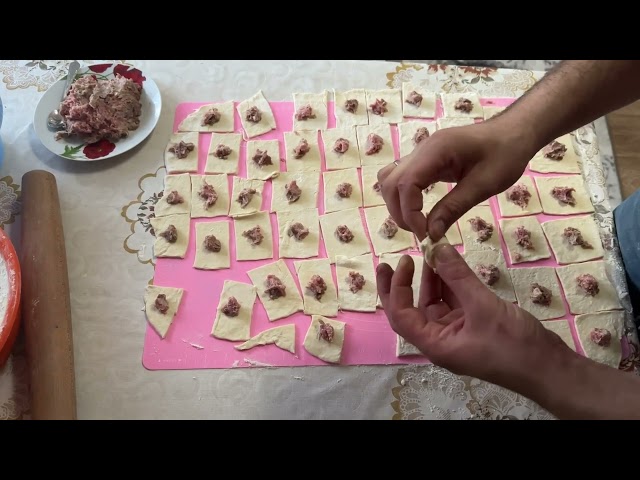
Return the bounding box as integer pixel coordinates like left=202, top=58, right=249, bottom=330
left=293, top=258, right=338, bottom=317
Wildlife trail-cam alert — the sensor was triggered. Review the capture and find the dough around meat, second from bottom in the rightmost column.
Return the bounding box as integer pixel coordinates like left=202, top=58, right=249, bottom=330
left=556, top=260, right=622, bottom=315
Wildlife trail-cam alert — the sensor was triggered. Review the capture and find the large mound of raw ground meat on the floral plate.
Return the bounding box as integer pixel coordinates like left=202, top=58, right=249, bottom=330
left=56, top=74, right=142, bottom=143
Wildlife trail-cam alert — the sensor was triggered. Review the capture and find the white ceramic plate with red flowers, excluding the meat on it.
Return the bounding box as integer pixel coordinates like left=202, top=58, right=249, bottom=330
left=33, top=63, right=162, bottom=162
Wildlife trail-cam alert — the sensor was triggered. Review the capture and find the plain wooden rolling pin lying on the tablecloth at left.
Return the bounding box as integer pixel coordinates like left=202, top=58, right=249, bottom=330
left=20, top=170, right=76, bottom=420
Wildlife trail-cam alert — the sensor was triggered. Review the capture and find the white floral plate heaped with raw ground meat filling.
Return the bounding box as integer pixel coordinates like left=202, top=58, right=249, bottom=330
left=33, top=63, right=162, bottom=161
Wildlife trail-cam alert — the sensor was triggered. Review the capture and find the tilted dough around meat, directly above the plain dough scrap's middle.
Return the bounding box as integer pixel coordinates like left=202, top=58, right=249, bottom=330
left=247, top=259, right=303, bottom=322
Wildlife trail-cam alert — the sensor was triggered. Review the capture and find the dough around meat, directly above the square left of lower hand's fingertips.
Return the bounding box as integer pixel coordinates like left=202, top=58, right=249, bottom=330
left=320, top=208, right=371, bottom=263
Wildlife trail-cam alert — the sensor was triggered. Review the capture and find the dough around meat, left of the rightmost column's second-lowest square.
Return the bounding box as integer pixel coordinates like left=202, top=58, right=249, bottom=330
left=509, top=267, right=567, bottom=320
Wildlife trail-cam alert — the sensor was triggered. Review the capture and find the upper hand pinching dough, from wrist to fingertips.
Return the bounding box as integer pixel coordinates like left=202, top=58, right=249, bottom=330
left=378, top=118, right=540, bottom=242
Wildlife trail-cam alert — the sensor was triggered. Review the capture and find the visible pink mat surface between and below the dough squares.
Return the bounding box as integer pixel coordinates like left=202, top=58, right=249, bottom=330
left=143, top=95, right=612, bottom=370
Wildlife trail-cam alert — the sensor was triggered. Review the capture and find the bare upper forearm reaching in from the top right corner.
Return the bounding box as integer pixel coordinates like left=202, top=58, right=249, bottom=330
left=495, top=60, right=640, bottom=150
